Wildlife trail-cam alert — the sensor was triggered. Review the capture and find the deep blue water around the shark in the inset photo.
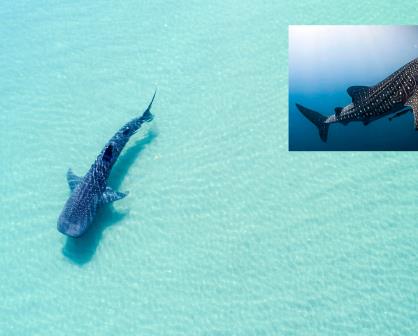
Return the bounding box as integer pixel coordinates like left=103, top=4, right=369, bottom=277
left=289, top=25, right=418, bottom=151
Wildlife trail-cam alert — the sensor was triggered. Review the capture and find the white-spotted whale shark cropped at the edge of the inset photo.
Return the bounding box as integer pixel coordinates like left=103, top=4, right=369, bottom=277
left=296, top=58, right=418, bottom=142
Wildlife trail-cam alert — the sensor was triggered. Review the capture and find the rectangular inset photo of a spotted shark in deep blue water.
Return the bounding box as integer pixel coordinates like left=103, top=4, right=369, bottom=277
left=289, top=25, right=418, bottom=151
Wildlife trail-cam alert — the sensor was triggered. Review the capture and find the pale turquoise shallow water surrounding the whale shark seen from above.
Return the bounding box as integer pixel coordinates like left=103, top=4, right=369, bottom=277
left=0, top=1, right=418, bottom=336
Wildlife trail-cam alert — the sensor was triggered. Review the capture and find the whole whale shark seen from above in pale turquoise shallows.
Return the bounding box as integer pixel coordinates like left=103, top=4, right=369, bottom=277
left=57, top=92, right=156, bottom=237
